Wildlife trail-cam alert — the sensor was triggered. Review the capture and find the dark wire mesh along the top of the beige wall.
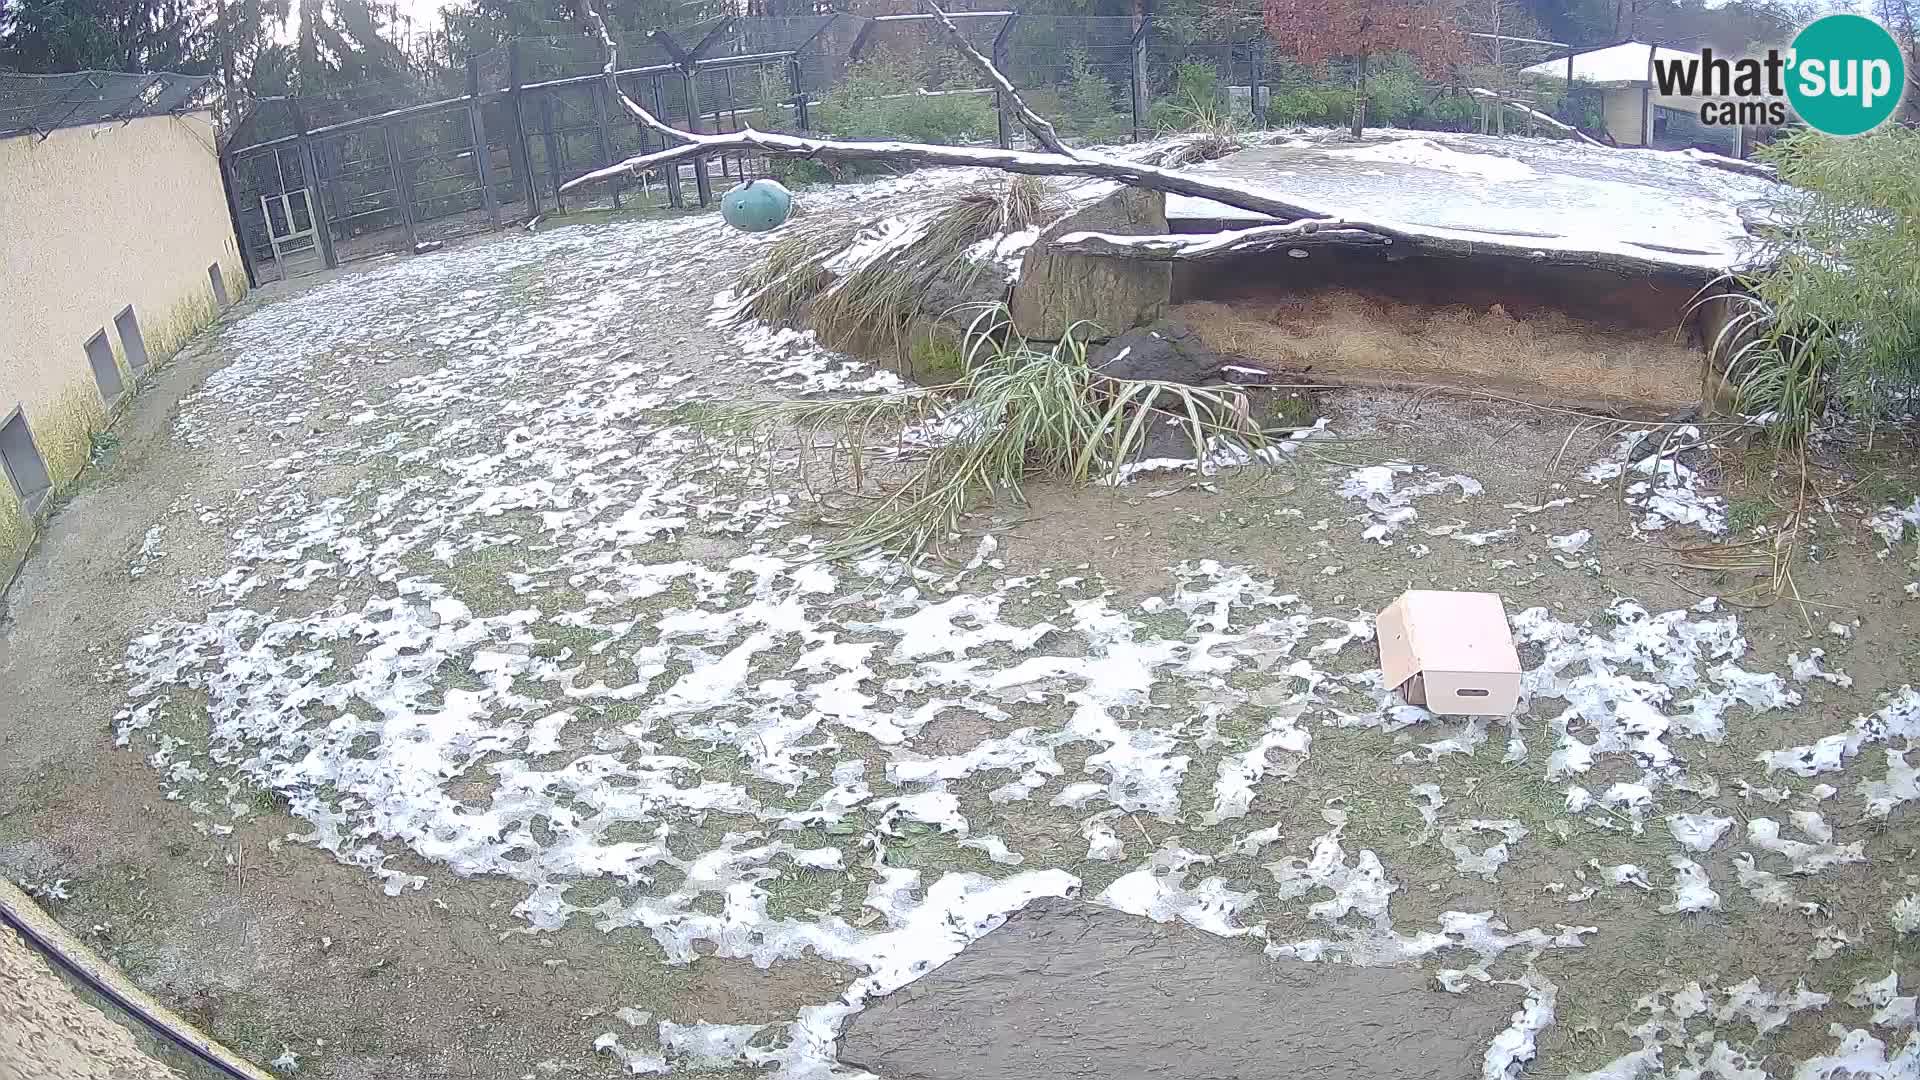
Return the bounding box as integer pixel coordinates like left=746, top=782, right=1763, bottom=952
left=0, top=71, right=213, bottom=138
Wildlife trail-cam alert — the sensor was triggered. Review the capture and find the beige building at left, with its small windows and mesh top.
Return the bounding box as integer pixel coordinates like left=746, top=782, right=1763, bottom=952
left=0, top=71, right=248, bottom=582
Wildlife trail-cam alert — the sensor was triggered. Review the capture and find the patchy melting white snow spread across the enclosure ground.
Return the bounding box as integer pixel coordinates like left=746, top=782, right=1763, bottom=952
left=3, top=161, right=1920, bottom=1080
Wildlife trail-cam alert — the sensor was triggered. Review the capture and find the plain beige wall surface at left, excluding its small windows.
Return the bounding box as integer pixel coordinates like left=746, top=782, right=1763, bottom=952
left=0, top=113, right=246, bottom=572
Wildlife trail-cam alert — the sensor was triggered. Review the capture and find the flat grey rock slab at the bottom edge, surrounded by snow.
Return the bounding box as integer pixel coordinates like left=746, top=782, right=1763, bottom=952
left=839, top=899, right=1521, bottom=1080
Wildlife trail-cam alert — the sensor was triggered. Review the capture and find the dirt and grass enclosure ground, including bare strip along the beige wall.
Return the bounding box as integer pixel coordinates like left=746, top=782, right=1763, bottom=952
left=0, top=168, right=1920, bottom=1080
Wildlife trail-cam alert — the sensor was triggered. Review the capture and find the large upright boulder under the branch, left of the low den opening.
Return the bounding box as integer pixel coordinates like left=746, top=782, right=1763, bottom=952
left=1010, top=188, right=1173, bottom=342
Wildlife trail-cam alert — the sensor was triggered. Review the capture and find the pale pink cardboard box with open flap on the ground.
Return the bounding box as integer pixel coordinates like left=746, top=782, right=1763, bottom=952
left=1375, top=590, right=1521, bottom=717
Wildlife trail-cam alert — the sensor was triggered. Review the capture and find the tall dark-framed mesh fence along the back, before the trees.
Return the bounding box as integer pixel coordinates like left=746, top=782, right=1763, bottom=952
left=223, top=6, right=1612, bottom=279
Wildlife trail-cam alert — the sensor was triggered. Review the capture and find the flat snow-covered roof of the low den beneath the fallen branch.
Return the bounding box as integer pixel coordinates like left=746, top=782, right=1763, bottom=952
left=1167, top=131, right=1780, bottom=273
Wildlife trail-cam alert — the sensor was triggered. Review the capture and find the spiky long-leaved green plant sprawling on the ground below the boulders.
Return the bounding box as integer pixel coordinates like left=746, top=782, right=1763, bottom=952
left=697, top=306, right=1267, bottom=557
